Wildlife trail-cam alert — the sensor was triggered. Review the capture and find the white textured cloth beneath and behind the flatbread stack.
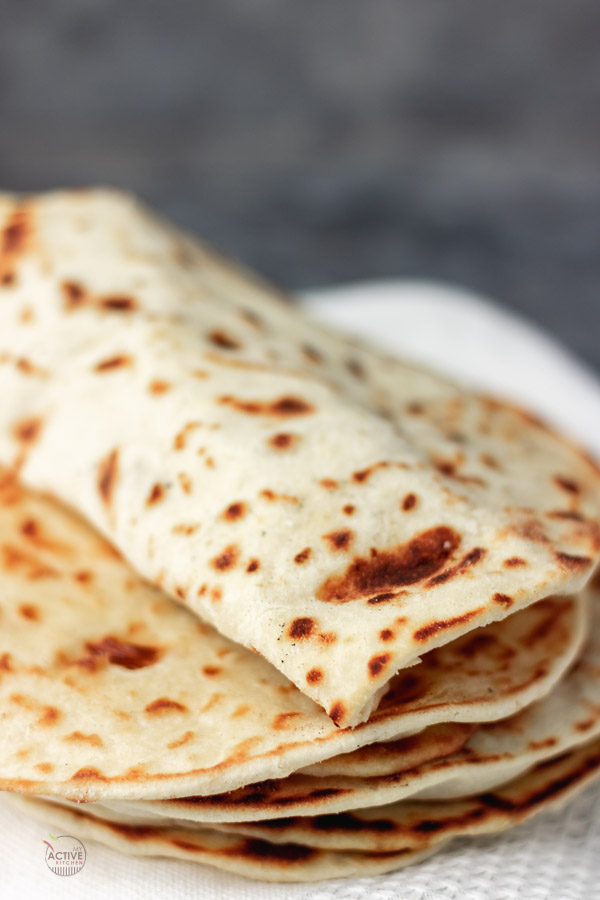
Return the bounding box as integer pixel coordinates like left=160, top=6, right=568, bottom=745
left=0, top=282, right=600, bottom=900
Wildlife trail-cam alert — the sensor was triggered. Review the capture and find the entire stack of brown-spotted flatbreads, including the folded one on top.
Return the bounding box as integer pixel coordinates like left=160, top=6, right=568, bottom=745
left=0, top=191, right=600, bottom=881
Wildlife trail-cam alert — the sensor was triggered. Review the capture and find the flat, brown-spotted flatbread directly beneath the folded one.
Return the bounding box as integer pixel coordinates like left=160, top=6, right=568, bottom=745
left=0, top=478, right=587, bottom=800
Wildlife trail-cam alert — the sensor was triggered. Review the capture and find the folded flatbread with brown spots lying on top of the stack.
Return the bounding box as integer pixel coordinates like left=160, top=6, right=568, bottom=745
left=0, top=191, right=600, bottom=726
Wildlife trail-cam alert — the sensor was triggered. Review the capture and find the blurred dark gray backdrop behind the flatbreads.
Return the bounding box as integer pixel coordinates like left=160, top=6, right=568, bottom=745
left=0, top=0, right=600, bottom=368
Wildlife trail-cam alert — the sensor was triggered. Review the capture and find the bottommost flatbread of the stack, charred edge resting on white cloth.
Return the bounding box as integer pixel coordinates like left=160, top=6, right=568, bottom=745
left=10, top=740, right=600, bottom=881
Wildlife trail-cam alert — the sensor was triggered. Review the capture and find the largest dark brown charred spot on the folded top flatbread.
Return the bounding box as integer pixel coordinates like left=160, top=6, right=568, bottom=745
left=317, top=525, right=460, bottom=603
